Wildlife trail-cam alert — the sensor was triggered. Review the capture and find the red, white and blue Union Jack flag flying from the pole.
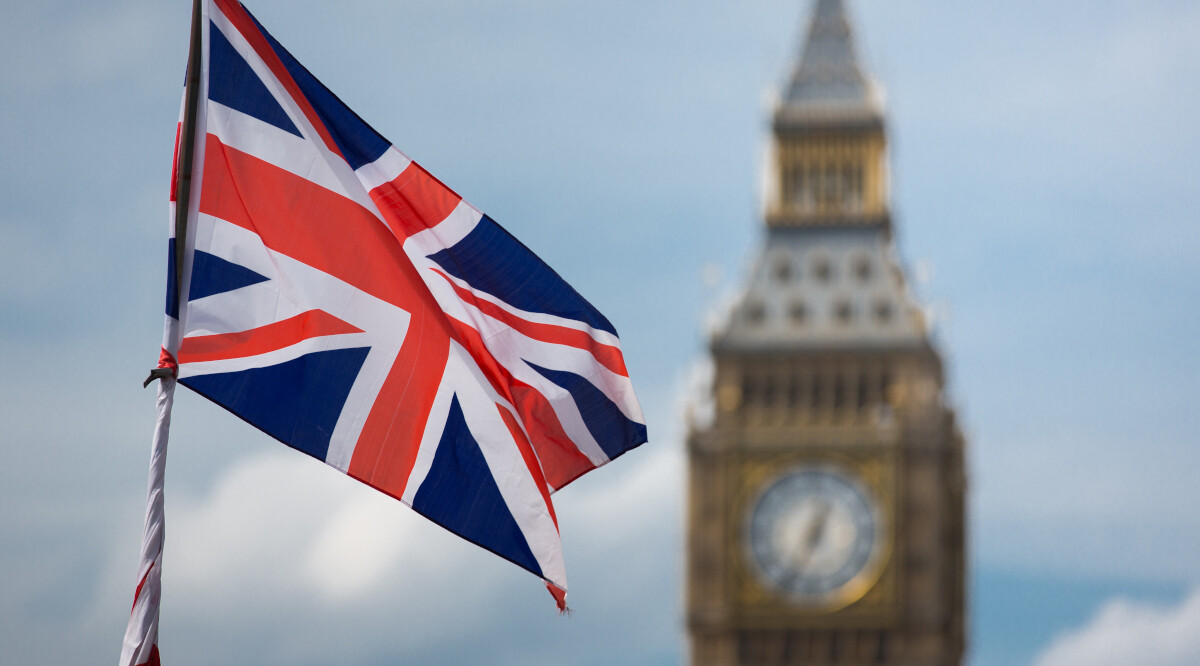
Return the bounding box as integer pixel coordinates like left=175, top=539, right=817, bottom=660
left=126, top=0, right=647, bottom=662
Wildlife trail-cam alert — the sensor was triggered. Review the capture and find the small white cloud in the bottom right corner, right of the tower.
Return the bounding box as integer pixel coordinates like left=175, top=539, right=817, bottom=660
left=1036, top=589, right=1200, bottom=666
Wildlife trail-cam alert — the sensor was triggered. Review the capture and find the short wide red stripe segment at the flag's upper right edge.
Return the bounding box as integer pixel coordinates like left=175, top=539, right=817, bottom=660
left=371, top=162, right=462, bottom=240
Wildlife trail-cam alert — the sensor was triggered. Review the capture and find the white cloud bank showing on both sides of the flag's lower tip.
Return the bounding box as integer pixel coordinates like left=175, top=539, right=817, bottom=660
left=156, top=427, right=682, bottom=611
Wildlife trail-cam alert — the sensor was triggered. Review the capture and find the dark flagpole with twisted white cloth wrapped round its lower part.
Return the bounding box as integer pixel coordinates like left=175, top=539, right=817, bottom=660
left=119, top=0, right=203, bottom=666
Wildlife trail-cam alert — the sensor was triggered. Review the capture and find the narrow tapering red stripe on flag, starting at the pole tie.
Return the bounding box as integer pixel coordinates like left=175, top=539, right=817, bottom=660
left=179, top=310, right=362, bottom=364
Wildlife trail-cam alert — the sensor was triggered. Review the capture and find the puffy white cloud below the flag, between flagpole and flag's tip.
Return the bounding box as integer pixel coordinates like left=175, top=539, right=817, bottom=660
left=164, top=450, right=482, bottom=613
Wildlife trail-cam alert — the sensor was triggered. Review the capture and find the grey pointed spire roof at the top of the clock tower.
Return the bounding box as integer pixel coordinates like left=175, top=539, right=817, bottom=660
left=779, top=0, right=882, bottom=120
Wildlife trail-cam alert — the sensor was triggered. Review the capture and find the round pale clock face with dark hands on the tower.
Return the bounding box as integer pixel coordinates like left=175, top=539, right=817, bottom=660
left=746, top=466, right=884, bottom=606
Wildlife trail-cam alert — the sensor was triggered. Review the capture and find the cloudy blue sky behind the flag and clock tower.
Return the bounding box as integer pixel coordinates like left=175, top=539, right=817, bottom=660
left=0, top=0, right=1200, bottom=666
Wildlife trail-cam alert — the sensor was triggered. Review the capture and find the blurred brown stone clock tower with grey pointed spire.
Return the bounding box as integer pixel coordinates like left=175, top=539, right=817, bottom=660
left=688, top=0, right=965, bottom=666
